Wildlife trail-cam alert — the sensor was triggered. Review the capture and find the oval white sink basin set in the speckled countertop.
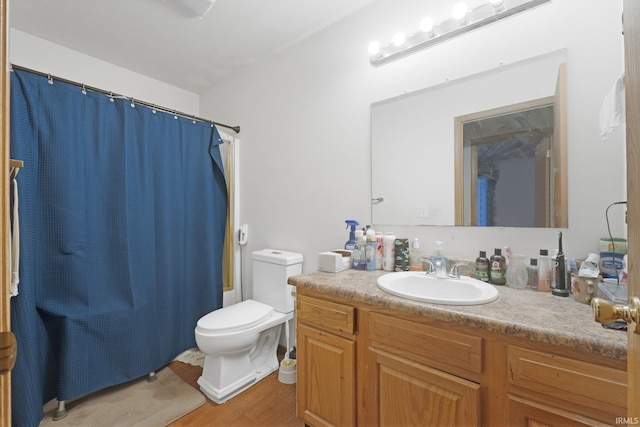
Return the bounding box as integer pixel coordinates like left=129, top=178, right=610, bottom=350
left=378, top=271, right=498, bottom=305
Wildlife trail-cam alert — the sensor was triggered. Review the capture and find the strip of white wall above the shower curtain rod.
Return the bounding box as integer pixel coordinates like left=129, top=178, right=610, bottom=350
left=9, top=29, right=200, bottom=116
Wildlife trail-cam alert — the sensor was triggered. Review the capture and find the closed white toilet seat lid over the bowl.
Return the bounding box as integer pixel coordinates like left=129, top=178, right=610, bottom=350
left=198, top=300, right=273, bottom=333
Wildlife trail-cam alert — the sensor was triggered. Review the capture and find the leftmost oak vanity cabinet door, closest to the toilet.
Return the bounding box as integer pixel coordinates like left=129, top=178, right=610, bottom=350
left=297, top=324, right=356, bottom=426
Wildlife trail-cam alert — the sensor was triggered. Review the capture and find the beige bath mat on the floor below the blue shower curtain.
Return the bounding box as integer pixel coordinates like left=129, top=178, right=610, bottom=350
left=40, top=367, right=205, bottom=427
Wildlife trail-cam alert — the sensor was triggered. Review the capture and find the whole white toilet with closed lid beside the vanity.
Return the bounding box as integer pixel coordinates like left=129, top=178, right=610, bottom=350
left=195, top=249, right=302, bottom=403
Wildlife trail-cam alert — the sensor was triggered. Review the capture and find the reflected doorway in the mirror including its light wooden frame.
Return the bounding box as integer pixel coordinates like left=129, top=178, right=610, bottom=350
left=454, top=64, right=568, bottom=228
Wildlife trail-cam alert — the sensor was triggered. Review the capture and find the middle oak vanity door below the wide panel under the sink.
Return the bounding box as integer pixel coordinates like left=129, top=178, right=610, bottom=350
left=368, top=349, right=480, bottom=427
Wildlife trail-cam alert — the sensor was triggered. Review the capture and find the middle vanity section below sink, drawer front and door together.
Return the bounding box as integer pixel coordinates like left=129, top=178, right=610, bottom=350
left=360, top=313, right=482, bottom=426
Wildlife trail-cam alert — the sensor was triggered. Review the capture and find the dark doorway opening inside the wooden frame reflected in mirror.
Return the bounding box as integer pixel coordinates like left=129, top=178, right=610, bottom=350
left=463, top=105, right=553, bottom=227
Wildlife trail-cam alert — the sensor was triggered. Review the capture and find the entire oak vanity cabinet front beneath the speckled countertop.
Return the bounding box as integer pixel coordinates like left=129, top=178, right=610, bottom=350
left=297, top=289, right=627, bottom=427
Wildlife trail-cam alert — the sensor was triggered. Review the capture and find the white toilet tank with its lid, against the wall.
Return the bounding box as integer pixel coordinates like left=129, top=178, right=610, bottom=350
left=252, top=249, right=302, bottom=313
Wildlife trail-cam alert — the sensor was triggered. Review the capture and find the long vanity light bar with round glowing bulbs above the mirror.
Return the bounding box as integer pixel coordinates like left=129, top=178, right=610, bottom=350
left=369, top=0, right=551, bottom=67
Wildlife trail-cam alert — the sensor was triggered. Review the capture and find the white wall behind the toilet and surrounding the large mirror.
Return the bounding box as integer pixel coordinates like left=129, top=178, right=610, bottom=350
left=201, top=0, right=625, bottom=294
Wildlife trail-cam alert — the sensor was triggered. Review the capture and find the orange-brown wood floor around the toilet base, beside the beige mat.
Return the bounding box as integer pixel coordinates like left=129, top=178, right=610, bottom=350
left=169, top=361, right=304, bottom=427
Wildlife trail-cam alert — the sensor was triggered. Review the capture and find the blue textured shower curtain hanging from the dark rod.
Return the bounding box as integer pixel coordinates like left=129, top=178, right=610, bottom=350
left=11, top=70, right=227, bottom=427
